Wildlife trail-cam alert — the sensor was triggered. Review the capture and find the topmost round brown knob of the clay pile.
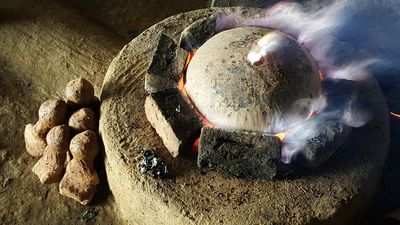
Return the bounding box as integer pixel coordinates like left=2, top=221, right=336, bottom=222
left=65, top=78, right=94, bottom=105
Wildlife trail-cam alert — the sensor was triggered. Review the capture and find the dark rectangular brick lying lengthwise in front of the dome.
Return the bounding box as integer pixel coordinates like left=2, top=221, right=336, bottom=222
left=197, top=127, right=283, bottom=180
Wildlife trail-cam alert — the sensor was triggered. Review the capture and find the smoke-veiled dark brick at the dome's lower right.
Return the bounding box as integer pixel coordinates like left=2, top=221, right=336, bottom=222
left=285, top=118, right=351, bottom=168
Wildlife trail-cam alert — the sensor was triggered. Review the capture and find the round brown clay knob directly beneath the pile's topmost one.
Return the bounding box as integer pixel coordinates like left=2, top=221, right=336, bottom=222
left=68, top=108, right=97, bottom=133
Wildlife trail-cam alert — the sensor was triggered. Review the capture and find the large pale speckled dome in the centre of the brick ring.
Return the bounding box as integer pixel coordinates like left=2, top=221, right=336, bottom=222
left=185, top=27, right=321, bottom=132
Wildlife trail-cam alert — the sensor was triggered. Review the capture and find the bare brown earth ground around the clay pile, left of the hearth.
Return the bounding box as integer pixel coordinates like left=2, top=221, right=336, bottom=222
left=0, top=0, right=206, bottom=224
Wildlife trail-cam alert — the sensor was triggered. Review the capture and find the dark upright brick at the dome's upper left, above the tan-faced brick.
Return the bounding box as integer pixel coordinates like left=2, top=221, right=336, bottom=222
left=145, top=34, right=187, bottom=94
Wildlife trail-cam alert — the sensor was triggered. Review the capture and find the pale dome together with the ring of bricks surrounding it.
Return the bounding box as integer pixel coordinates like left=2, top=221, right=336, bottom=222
left=145, top=15, right=358, bottom=180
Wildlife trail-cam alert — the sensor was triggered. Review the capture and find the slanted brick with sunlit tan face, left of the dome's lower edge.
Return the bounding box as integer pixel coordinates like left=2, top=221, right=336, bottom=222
left=145, top=90, right=202, bottom=157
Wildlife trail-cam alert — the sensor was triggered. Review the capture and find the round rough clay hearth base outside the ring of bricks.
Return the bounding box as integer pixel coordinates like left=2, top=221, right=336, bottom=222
left=100, top=8, right=388, bottom=224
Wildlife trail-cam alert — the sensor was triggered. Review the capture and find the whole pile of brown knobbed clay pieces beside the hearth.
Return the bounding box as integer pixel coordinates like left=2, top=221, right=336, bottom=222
left=24, top=78, right=100, bottom=205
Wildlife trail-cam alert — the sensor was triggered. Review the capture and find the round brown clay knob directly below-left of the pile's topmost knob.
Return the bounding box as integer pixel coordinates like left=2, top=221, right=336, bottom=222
left=39, top=99, right=67, bottom=128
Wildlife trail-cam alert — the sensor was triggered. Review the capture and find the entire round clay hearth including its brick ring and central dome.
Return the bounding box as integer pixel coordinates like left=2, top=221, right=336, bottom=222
left=99, top=5, right=388, bottom=224
